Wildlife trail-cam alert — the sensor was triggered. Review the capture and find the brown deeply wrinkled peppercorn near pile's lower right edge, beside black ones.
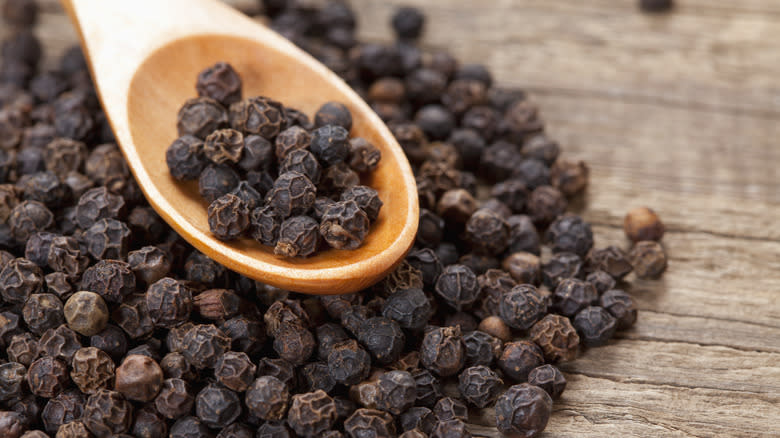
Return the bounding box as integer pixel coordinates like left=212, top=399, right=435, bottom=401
left=529, top=315, right=580, bottom=363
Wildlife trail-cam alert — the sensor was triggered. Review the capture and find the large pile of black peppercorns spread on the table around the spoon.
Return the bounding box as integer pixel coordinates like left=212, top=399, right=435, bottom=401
left=0, top=0, right=666, bottom=438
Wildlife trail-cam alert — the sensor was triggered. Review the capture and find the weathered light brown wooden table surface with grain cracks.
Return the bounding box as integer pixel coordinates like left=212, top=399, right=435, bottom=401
left=25, top=0, right=780, bottom=437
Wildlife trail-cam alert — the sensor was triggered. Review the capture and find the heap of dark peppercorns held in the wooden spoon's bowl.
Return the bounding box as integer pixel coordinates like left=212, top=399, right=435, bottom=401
left=166, top=62, right=382, bottom=257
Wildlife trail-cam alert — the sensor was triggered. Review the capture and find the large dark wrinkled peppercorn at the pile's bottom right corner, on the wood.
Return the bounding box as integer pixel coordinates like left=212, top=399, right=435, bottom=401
left=495, top=383, right=552, bottom=437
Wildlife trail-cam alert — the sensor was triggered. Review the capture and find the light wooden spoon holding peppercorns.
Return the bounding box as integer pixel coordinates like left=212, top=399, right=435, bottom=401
left=62, top=0, right=418, bottom=294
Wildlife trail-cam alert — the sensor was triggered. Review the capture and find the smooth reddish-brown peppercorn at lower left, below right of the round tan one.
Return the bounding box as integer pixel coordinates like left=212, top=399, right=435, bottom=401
left=114, top=354, right=163, bottom=402
